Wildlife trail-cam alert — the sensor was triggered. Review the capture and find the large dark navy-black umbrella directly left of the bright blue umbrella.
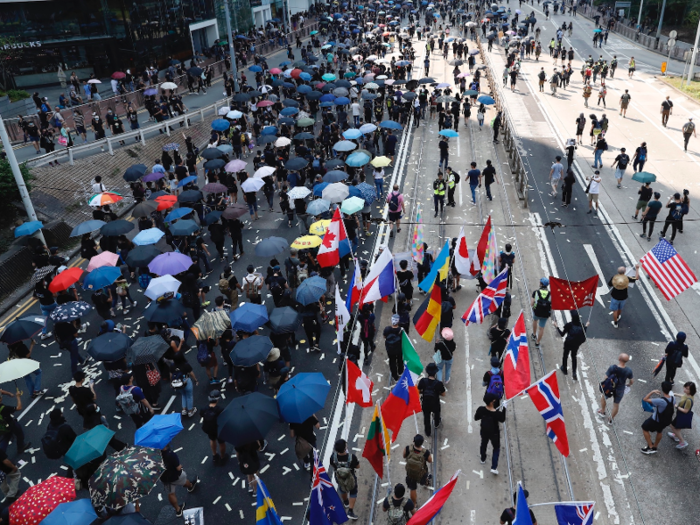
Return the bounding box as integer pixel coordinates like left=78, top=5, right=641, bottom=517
left=217, top=390, right=280, bottom=447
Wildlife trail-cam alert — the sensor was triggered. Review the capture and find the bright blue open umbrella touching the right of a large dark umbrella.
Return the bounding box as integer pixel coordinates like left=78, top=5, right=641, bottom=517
left=277, top=372, right=331, bottom=423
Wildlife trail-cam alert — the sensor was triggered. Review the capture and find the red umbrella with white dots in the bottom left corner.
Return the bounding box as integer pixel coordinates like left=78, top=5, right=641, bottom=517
left=10, top=476, right=75, bottom=525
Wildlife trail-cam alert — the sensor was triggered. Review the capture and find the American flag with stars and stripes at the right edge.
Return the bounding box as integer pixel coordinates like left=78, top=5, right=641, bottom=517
left=640, top=239, right=698, bottom=301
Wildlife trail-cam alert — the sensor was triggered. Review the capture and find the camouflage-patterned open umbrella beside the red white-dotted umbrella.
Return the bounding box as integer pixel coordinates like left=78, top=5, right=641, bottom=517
left=87, top=447, right=165, bottom=509
